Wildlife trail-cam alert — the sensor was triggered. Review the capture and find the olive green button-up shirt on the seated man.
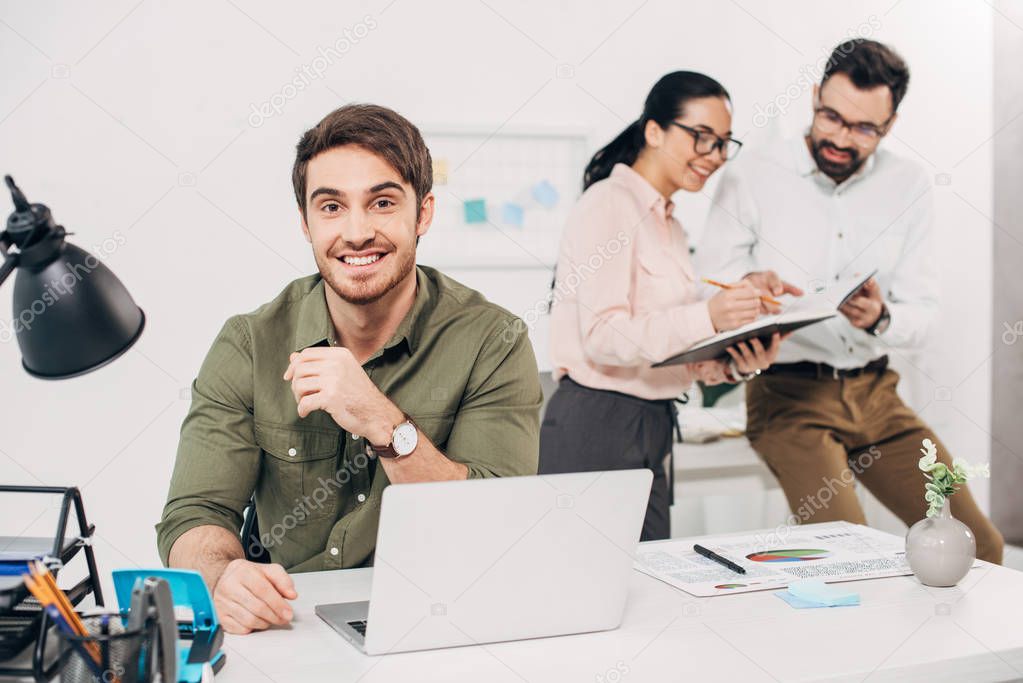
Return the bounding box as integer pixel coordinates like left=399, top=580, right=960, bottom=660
left=157, top=266, right=542, bottom=572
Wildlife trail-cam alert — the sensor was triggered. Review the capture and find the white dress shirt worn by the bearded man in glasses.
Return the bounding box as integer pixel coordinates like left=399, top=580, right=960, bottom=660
left=696, top=132, right=938, bottom=368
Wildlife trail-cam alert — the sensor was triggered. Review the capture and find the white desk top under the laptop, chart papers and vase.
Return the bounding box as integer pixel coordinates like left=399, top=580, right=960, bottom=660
left=216, top=527, right=1023, bottom=683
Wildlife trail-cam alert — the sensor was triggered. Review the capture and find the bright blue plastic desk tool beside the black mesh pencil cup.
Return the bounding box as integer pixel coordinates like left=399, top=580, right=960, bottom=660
left=113, top=568, right=225, bottom=683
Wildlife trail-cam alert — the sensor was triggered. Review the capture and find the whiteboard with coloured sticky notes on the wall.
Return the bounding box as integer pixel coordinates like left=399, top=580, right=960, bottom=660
left=417, top=126, right=588, bottom=270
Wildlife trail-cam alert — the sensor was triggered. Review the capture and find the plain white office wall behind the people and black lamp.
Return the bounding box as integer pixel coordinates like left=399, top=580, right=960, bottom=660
left=0, top=0, right=993, bottom=572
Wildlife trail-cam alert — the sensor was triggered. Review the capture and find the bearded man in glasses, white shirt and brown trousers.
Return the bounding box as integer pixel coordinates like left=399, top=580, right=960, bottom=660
left=696, top=39, right=1003, bottom=563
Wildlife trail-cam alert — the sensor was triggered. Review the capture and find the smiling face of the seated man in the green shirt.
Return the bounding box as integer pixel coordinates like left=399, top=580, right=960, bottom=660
left=302, top=144, right=434, bottom=305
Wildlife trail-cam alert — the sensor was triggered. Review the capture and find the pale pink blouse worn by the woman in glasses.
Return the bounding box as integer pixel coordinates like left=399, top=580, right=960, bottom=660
left=550, top=164, right=725, bottom=399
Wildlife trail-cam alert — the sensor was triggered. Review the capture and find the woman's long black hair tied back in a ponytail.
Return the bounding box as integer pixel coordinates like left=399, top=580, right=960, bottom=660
left=582, top=72, right=730, bottom=190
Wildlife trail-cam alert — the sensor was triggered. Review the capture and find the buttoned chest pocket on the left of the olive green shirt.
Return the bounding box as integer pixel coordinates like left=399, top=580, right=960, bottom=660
left=256, top=421, right=342, bottom=522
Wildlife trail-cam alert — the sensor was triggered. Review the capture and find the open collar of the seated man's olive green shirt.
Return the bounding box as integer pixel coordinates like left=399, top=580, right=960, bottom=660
left=292, top=267, right=436, bottom=357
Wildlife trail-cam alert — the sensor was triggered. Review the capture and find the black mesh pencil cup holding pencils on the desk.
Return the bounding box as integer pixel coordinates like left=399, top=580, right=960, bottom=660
left=60, top=614, right=152, bottom=683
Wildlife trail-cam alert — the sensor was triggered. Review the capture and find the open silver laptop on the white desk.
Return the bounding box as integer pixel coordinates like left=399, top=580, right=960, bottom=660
left=316, top=469, right=653, bottom=654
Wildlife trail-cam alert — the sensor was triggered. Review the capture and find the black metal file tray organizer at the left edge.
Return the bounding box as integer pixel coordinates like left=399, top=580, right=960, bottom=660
left=0, top=486, right=103, bottom=683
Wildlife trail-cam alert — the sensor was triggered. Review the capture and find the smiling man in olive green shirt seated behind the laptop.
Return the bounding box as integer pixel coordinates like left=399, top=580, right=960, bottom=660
left=157, top=104, right=541, bottom=633
